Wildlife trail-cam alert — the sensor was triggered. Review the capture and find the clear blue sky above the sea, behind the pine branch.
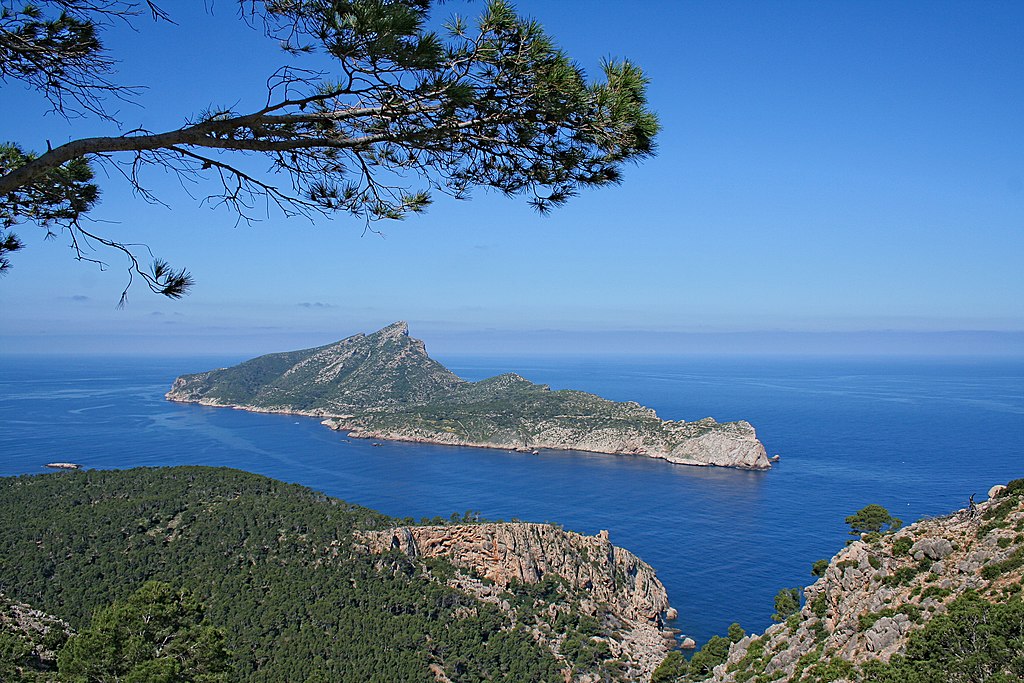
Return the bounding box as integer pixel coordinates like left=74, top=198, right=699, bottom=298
left=0, top=0, right=1024, bottom=354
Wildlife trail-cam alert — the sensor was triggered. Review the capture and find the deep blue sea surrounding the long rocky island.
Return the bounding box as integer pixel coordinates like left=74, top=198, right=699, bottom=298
left=0, top=356, right=1024, bottom=641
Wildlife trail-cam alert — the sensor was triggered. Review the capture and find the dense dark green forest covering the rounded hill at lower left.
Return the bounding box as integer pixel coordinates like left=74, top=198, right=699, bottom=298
left=0, top=467, right=614, bottom=683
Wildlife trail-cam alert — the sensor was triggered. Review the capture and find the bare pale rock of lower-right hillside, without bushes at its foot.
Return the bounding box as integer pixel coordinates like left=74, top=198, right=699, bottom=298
left=710, top=480, right=1024, bottom=683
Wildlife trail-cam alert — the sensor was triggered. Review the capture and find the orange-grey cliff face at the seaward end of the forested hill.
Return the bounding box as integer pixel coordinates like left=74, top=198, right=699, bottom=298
left=355, top=522, right=676, bottom=681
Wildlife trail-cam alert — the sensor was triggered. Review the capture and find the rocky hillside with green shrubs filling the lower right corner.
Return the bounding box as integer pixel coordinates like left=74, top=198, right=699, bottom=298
left=696, top=479, right=1024, bottom=683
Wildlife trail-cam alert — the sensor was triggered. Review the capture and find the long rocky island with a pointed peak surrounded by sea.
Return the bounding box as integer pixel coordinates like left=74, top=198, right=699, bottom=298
left=166, top=322, right=771, bottom=470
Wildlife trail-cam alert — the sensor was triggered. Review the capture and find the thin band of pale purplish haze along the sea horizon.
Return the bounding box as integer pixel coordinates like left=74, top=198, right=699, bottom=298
left=0, top=327, right=1024, bottom=358
